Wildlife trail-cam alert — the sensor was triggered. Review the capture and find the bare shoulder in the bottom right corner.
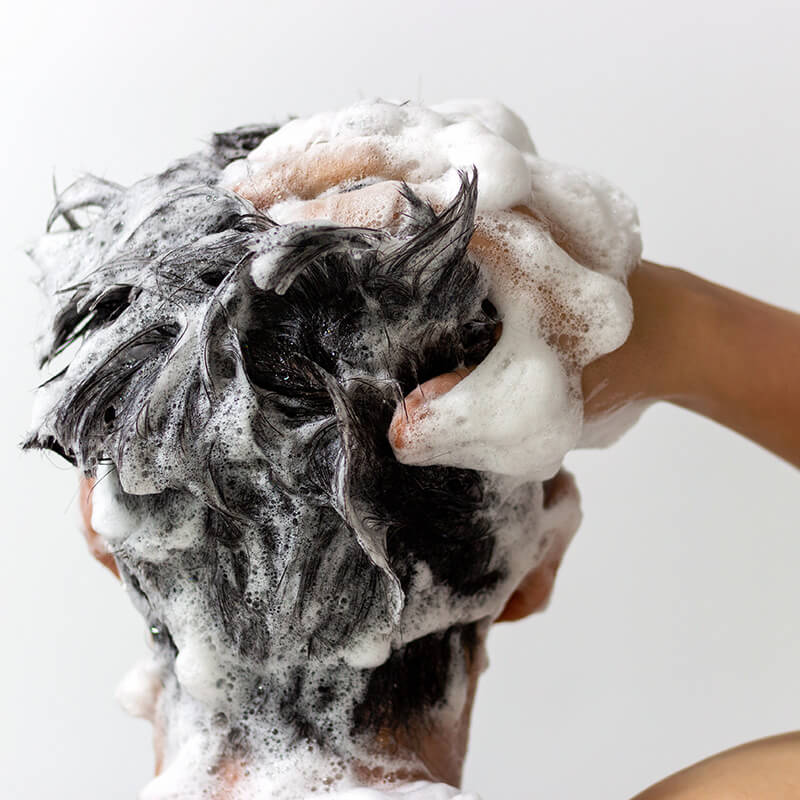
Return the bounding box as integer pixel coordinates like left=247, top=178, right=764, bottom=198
left=633, top=731, right=800, bottom=800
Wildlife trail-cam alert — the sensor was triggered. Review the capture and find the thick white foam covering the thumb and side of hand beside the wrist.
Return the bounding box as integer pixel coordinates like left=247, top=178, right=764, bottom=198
left=395, top=206, right=633, bottom=480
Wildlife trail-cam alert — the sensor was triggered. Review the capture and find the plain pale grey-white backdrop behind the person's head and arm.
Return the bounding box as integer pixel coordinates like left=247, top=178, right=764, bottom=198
left=0, top=0, right=800, bottom=800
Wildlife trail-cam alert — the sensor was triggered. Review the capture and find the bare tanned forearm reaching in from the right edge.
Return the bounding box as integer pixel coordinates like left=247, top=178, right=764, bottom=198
left=584, top=262, right=800, bottom=467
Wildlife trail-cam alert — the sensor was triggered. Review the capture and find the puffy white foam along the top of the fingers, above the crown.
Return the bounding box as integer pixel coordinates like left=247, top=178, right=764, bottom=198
left=221, top=101, right=533, bottom=216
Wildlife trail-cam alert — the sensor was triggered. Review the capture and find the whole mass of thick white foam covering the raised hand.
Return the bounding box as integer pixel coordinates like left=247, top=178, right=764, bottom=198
left=223, top=100, right=641, bottom=480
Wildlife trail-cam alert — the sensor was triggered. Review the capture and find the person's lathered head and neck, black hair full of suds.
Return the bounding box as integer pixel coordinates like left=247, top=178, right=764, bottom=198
left=26, top=120, right=579, bottom=798
